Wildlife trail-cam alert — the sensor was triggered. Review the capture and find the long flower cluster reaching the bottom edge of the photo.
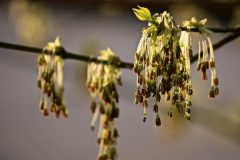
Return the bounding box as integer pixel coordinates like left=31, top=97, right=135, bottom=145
left=86, top=48, right=121, bottom=160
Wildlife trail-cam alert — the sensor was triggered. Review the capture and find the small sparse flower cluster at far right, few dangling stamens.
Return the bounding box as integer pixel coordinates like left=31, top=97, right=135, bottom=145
left=183, top=17, right=219, bottom=98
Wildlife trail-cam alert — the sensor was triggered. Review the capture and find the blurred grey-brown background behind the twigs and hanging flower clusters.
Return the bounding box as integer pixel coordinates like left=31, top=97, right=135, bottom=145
left=0, top=0, right=240, bottom=160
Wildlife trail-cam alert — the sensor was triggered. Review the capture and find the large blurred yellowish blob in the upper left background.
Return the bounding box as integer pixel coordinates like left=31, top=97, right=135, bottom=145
left=8, top=0, right=54, bottom=45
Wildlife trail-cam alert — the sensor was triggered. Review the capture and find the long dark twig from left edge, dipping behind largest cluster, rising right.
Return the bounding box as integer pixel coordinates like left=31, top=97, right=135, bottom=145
left=0, top=29, right=240, bottom=69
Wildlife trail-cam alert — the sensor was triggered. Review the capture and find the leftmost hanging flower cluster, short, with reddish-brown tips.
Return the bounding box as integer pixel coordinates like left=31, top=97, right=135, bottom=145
left=37, top=37, right=68, bottom=118
